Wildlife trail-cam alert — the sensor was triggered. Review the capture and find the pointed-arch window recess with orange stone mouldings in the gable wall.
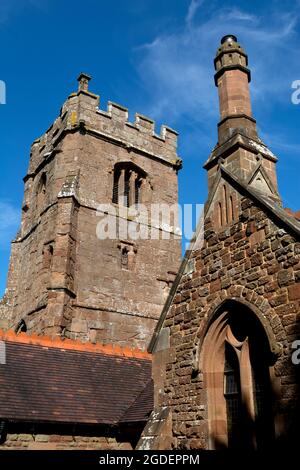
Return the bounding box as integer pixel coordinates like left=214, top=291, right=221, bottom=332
left=201, top=301, right=274, bottom=450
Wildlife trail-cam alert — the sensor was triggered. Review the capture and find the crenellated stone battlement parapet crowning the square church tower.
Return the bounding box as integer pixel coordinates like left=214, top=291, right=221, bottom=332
left=27, top=74, right=181, bottom=177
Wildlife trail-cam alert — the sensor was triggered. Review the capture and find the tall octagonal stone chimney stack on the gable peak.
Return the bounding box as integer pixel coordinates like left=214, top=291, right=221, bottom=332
left=204, top=34, right=280, bottom=206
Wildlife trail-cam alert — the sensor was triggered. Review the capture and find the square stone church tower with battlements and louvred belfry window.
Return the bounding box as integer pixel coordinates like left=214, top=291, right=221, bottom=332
left=0, top=74, right=181, bottom=348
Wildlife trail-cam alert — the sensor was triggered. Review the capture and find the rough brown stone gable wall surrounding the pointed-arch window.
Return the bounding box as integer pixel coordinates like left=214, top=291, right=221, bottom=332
left=153, top=198, right=300, bottom=448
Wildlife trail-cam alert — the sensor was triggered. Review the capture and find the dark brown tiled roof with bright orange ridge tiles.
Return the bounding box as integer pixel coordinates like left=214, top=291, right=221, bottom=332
left=0, top=334, right=153, bottom=424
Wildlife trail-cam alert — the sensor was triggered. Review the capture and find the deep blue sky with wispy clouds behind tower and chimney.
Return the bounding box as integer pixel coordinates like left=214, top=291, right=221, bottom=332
left=0, top=0, right=300, bottom=294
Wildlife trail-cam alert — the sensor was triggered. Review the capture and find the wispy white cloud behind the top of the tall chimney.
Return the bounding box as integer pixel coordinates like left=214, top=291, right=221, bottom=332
left=137, top=0, right=299, bottom=125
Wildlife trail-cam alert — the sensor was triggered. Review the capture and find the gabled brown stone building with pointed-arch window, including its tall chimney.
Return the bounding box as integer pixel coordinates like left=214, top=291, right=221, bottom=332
left=139, top=35, right=300, bottom=450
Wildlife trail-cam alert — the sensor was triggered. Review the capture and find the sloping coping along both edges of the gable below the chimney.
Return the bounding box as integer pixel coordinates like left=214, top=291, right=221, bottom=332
left=148, top=164, right=300, bottom=353
